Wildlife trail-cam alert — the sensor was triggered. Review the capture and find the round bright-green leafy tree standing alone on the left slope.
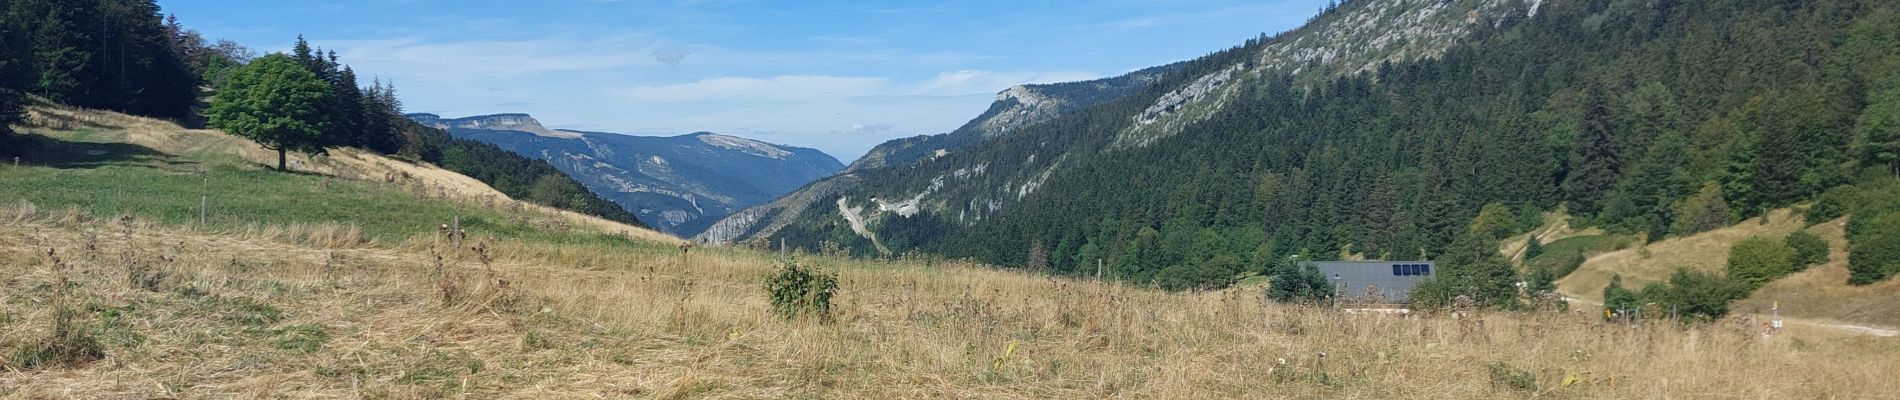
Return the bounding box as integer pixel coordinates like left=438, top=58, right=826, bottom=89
left=205, top=53, right=331, bottom=171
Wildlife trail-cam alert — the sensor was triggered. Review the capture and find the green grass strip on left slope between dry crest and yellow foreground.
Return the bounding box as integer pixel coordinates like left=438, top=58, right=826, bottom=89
left=0, top=133, right=661, bottom=246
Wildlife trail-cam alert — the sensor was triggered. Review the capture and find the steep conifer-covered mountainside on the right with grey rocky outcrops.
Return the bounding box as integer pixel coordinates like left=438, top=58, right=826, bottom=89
left=714, top=0, right=1900, bottom=288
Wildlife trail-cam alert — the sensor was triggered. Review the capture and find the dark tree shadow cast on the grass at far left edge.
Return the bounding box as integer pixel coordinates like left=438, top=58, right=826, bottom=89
left=0, top=135, right=198, bottom=169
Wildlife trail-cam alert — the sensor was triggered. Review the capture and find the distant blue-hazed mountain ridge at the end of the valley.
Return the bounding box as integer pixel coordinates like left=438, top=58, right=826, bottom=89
left=409, top=114, right=844, bottom=237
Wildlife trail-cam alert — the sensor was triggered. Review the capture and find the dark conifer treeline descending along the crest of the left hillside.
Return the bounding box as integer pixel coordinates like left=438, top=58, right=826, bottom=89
left=0, top=0, right=644, bottom=226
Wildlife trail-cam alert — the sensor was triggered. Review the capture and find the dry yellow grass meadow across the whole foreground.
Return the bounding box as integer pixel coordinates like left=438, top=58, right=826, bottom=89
left=0, top=205, right=1900, bottom=398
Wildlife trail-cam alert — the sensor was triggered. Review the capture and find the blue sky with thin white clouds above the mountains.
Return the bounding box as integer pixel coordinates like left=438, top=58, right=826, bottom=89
left=158, top=0, right=1324, bottom=163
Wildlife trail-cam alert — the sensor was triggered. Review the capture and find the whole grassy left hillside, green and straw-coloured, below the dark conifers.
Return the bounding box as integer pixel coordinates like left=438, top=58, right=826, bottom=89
left=0, top=106, right=667, bottom=241
